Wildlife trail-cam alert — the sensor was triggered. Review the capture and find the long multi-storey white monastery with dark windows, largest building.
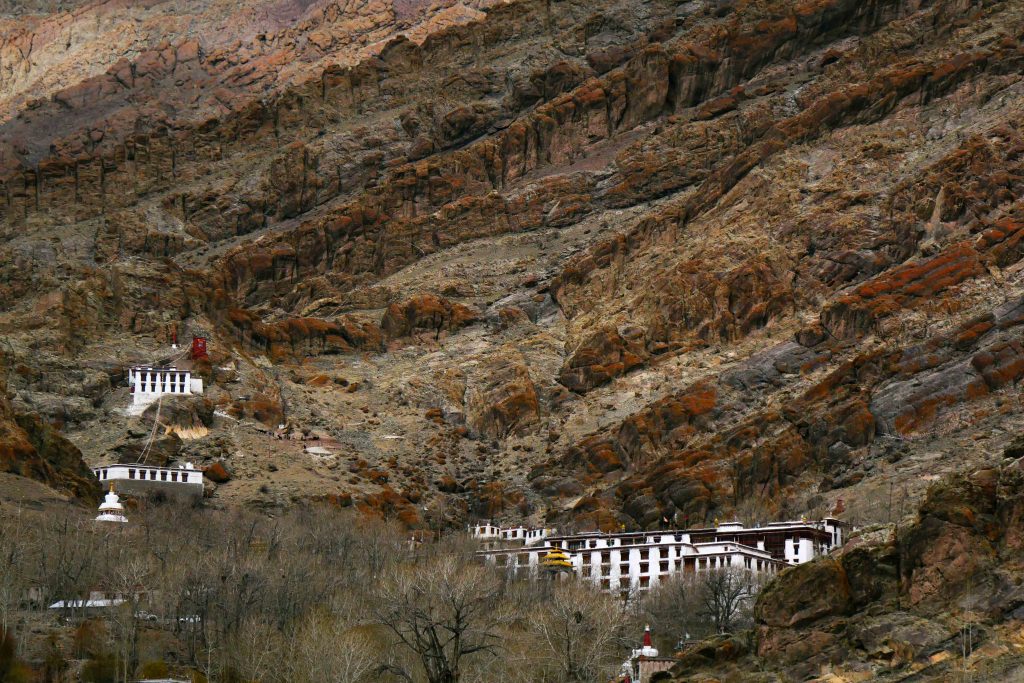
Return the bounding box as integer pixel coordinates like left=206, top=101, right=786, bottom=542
left=469, top=518, right=843, bottom=592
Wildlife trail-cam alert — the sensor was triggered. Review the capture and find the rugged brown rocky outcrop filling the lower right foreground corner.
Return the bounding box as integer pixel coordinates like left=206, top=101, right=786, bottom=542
left=674, top=461, right=1024, bottom=681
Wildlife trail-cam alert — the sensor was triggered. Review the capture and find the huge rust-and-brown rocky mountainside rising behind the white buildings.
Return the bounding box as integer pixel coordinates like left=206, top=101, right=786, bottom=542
left=0, top=0, right=1024, bottom=527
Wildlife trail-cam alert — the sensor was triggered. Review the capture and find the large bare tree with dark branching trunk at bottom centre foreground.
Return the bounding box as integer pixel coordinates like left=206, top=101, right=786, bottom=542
left=376, top=553, right=502, bottom=683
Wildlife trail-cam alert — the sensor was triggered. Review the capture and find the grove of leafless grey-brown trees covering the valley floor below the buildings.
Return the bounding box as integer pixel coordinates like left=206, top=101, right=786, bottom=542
left=0, top=506, right=655, bottom=683
